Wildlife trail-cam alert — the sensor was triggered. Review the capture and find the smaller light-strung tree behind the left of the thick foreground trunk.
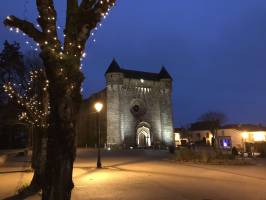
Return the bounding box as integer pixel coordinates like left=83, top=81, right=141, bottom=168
left=4, top=68, right=49, bottom=197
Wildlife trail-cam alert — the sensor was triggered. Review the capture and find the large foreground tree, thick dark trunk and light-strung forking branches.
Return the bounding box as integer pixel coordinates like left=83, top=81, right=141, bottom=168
left=4, top=0, right=115, bottom=200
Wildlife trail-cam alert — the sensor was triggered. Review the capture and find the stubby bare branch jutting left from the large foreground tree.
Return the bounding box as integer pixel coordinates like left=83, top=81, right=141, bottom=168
left=4, top=16, right=44, bottom=43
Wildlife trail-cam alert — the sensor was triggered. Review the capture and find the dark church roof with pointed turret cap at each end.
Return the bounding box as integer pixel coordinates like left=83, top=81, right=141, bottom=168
left=105, top=59, right=172, bottom=80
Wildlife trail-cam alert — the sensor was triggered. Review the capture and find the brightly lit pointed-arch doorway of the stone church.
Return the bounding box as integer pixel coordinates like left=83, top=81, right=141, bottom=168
left=136, top=124, right=151, bottom=147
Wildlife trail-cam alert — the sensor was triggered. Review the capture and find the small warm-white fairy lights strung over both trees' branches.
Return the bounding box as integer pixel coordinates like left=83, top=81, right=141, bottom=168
left=3, top=0, right=115, bottom=110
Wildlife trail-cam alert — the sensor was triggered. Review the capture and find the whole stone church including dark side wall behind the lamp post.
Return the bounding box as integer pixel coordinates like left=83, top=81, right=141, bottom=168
left=77, top=60, right=174, bottom=147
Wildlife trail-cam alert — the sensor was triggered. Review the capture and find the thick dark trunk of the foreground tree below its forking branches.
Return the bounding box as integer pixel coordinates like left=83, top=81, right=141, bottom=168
left=42, top=55, right=82, bottom=200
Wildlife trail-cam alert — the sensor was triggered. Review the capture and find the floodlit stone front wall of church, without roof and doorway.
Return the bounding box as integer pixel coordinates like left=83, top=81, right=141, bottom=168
left=107, top=74, right=173, bottom=146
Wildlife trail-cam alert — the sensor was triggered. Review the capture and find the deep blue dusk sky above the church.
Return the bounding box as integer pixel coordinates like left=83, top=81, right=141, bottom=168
left=0, top=0, right=266, bottom=126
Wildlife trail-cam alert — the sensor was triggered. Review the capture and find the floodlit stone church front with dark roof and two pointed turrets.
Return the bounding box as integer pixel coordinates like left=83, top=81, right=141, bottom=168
left=105, top=60, right=173, bottom=147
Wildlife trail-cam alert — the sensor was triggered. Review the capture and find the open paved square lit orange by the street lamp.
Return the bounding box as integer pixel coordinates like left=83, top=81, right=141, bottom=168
left=0, top=150, right=266, bottom=200
